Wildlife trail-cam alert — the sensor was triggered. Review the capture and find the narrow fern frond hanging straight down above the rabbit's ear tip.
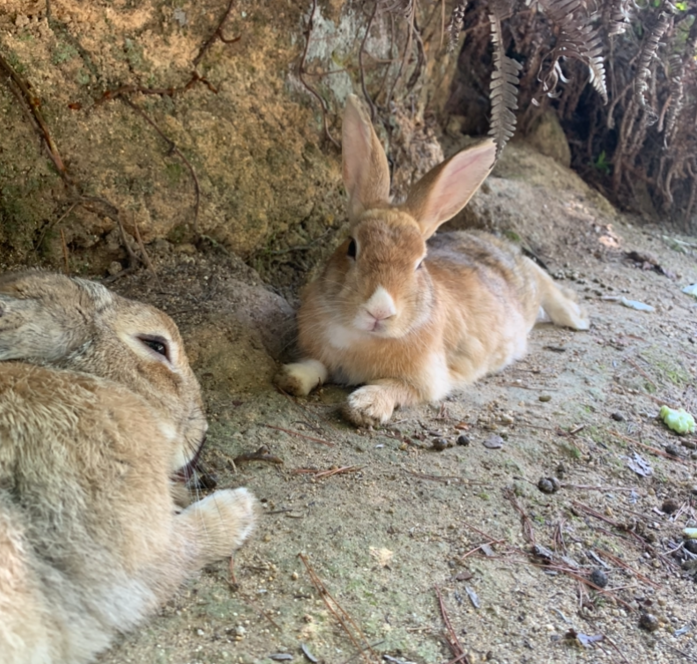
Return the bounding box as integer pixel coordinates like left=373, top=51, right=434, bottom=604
left=489, top=14, right=522, bottom=158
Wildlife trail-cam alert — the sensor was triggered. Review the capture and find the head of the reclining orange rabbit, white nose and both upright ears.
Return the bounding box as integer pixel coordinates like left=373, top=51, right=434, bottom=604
left=322, top=96, right=495, bottom=338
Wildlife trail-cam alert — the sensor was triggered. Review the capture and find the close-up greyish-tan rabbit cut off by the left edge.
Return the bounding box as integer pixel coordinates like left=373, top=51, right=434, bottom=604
left=0, top=272, right=255, bottom=664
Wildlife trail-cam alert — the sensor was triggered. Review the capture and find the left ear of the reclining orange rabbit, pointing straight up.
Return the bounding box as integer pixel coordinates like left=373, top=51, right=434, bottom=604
left=341, top=95, right=390, bottom=221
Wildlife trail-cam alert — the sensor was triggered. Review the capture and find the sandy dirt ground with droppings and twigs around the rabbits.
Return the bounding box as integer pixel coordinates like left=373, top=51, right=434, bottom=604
left=76, top=145, right=697, bottom=664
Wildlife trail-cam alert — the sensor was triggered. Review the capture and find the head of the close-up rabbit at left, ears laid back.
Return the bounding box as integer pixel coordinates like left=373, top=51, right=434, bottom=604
left=0, top=271, right=207, bottom=472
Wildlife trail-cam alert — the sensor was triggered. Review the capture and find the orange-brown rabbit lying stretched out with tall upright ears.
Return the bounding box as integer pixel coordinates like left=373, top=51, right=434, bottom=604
left=276, top=96, right=589, bottom=426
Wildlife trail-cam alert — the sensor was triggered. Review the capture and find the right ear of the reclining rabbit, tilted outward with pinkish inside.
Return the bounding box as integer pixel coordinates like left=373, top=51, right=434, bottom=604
left=402, top=139, right=496, bottom=238
